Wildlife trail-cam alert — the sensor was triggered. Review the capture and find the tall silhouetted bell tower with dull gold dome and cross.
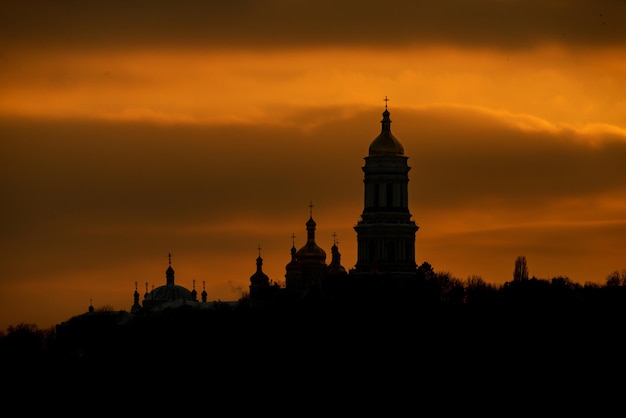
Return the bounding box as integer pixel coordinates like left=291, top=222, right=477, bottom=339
left=351, top=98, right=419, bottom=278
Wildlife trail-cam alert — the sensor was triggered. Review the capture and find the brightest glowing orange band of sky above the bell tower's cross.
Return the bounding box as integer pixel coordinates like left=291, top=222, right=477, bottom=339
left=0, top=47, right=626, bottom=127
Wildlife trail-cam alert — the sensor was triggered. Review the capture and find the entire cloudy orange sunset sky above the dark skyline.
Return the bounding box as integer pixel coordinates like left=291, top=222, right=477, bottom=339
left=0, top=0, right=626, bottom=329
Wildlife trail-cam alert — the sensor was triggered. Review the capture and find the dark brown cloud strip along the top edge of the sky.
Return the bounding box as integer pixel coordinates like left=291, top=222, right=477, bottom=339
left=0, top=0, right=626, bottom=49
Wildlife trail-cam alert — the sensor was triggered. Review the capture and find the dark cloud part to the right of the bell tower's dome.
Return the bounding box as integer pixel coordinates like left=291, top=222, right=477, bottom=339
left=394, top=107, right=626, bottom=205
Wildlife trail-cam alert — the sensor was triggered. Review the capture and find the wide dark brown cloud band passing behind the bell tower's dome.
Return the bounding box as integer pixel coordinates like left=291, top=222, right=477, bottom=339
left=2, top=107, right=626, bottom=224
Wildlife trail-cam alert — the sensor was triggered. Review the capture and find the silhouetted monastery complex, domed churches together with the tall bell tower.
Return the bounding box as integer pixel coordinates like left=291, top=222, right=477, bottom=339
left=131, top=103, right=419, bottom=313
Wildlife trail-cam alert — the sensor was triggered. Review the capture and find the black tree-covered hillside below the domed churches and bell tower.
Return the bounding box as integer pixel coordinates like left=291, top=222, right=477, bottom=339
left=0, top=259, right=626, bottom=408
